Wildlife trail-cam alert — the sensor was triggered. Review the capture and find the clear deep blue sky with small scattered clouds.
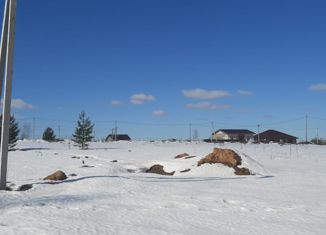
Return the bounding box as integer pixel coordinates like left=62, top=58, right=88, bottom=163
left=0, top=0, right=326, bottom=139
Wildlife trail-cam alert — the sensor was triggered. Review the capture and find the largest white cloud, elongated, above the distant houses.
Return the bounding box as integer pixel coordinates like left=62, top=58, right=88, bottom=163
left=182, top=88, right=231, bottom=100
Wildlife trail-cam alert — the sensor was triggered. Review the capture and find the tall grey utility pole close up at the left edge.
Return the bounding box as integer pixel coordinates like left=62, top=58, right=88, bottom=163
left=0, top=0, right=17, bottom=190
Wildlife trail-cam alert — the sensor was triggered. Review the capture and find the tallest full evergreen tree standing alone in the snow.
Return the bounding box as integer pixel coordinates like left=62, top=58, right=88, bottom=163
left=72, top=111, right=94, bottom=149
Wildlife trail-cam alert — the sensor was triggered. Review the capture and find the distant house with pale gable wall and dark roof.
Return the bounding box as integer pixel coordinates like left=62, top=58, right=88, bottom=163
left=212, top=129, right=255, bottom=141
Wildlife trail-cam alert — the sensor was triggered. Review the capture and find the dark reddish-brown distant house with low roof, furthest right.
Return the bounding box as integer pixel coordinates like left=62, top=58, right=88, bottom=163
left=254, top=130, right=298, bottom=144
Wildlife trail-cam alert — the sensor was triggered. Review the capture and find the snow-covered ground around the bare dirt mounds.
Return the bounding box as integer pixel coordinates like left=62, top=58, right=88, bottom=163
left=0, top=141, right=326, bottom=235
